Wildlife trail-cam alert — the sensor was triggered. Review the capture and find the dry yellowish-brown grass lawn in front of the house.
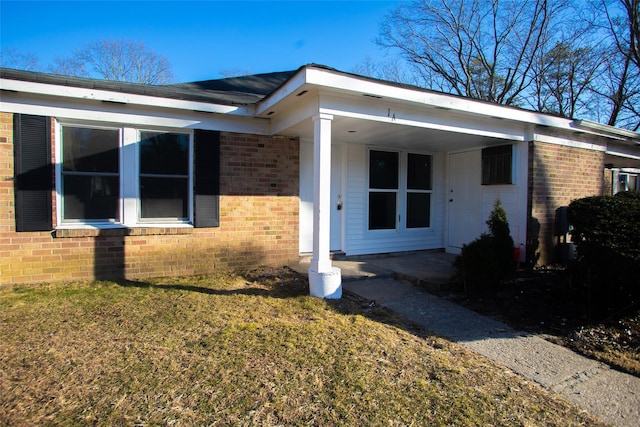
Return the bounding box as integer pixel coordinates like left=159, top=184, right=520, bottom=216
left=0, top=269, right=600, bottom=426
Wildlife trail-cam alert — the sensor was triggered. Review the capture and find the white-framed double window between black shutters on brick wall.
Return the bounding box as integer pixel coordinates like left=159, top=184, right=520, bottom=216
left=59, top=125, right=193, bottom=226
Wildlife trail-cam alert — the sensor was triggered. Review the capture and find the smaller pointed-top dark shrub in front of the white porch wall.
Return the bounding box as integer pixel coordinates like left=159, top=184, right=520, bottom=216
left=454, top=199, right=515, bottom=291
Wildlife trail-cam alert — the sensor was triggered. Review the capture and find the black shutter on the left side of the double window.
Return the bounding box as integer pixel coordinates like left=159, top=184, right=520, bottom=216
left=13, top=114, right=53, bottom=231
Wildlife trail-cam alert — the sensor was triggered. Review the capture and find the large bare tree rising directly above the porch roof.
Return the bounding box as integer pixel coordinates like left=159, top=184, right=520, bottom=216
left=378, top=0, right=563, bottom=105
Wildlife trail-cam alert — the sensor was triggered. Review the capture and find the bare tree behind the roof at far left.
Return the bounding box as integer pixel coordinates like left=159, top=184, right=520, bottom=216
left=51, top=40, right=173, bottom=84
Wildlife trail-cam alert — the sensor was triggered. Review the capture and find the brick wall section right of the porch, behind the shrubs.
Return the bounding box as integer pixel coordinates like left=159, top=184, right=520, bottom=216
left=527, top=142, right=604, bottom=265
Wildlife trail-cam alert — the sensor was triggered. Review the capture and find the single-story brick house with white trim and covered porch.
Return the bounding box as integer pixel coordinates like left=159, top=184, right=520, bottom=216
left=0, top=64, right=640, bottom=297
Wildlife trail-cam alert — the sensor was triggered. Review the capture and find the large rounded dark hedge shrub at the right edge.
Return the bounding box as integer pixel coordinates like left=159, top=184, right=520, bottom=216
left=567, top=192, right=640, bottom=315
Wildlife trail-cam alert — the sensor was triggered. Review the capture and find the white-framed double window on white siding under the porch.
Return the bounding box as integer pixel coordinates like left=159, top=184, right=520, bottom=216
left=369, top=150, right=433, bottom=230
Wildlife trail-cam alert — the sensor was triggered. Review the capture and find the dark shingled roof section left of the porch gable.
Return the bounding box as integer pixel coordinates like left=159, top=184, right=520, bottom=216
left=0, top=68, right=298, bottom=105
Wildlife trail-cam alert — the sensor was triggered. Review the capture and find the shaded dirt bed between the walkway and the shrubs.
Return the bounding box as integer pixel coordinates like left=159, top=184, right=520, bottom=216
left=434, top=269, right=640, bottom=377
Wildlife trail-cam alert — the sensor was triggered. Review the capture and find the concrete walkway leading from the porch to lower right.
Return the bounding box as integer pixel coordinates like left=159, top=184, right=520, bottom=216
left=293, top=252, right=640, bottom=427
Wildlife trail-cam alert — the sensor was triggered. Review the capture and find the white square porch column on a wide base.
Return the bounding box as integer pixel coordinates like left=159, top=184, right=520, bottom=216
left=309, top=114, right=342, bottom=298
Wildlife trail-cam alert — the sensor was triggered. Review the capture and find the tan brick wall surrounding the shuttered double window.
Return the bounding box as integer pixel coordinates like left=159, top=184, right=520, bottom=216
left=0, top=113, right=299, bottom=284
